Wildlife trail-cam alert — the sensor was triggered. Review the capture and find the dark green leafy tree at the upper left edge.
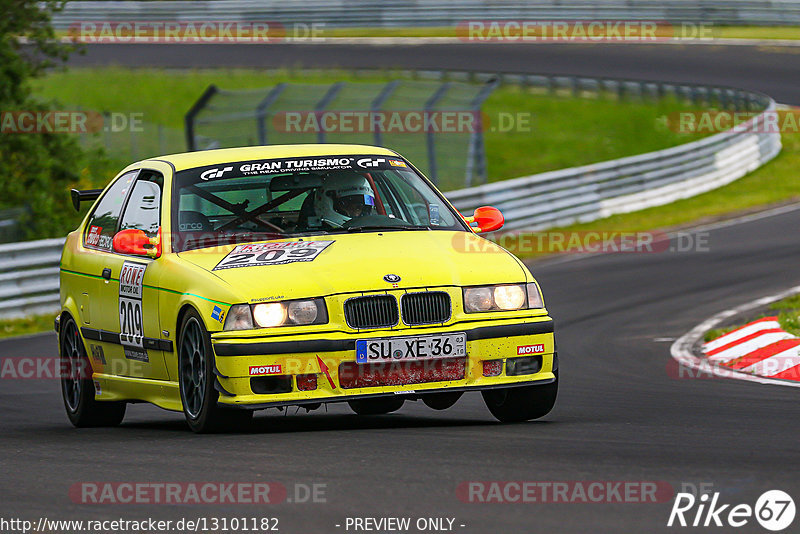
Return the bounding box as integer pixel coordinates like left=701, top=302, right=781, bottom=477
left=0, top=0, right=88, bottom=239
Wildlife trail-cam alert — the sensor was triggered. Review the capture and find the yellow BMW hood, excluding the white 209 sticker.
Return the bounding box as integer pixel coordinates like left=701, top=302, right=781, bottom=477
left=179, top=230, right=526, bottom=302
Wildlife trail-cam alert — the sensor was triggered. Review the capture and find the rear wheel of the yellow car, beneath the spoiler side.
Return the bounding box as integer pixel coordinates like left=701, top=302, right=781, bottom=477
left=58, top=316, right=126, bottom=428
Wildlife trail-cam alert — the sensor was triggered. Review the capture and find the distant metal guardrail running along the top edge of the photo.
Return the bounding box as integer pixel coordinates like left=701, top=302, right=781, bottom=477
left=53, top=0, right=800, bottom=29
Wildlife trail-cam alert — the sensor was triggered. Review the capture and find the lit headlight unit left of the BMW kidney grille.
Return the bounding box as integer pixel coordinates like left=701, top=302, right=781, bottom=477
left=225, top=299, right=328, bottom=330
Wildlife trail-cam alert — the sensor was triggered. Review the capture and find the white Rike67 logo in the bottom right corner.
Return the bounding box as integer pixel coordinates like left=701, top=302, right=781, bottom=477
left=667, top=490, right=796, bottom=532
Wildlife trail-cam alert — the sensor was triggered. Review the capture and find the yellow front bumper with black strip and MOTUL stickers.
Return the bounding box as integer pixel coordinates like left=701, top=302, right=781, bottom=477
left=212, top=315, right=558, bottom=409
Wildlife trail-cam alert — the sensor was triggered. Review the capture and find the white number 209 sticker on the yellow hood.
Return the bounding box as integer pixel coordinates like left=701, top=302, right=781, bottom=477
left=212, top=241, right=333, bottom=271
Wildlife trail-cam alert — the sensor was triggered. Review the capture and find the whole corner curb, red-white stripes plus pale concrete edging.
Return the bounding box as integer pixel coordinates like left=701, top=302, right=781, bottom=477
left=670, top=286, right=800, bottom=387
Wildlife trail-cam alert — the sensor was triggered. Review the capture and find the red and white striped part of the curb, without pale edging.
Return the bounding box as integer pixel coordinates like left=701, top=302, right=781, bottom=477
left=703, top=317, right=800, bottom=381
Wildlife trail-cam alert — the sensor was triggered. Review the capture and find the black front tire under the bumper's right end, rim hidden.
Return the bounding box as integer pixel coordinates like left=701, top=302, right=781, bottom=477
left=481, top=371, right=558, bottom=423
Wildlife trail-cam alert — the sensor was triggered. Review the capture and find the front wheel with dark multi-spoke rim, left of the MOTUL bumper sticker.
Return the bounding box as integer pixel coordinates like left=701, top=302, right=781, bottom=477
left=178, top=310, right=253, bottom=434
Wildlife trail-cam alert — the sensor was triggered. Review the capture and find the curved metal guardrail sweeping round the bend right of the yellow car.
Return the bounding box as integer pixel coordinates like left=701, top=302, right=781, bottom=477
left=447, top=101, right=781, bottom=231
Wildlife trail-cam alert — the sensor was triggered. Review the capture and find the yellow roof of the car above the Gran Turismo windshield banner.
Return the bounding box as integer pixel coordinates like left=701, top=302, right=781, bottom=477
left=143, top=144, right=397, bottom=171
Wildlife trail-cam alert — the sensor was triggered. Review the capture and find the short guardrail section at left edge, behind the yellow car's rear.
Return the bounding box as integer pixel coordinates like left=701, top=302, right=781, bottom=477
left=0, top=238, right=64, bottom=319
